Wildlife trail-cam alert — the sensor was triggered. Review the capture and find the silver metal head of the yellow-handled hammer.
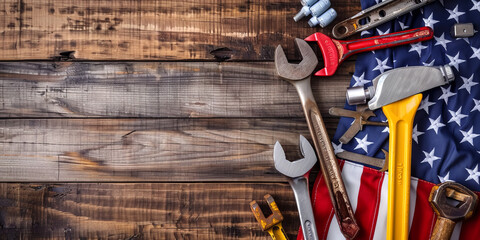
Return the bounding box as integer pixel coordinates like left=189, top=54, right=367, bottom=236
left=347, top=65, right=455, bottom=110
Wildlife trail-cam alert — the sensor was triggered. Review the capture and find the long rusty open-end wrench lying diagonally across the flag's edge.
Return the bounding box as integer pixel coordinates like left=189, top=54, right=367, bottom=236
left=275, top=38, right=360, bottom=239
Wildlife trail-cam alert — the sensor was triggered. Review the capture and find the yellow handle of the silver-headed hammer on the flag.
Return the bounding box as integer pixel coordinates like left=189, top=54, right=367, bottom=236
left=382, top=94, right=422, bottom=240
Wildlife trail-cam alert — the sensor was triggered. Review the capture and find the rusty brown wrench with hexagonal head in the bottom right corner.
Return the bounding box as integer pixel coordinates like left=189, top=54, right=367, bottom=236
left=428, top=182, right=478, bottom=240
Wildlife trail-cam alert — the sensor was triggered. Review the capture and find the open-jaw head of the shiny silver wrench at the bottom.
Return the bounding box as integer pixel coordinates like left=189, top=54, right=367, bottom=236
left=273, top=135, right=317, bottom=178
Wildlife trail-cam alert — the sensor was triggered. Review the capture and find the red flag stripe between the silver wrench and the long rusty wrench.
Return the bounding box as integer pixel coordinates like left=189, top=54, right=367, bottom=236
left=297, top=160, right=344, bottom=240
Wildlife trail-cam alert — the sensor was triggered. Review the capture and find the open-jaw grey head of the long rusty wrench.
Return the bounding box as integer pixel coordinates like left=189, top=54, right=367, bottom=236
left=275, top=38, right=318, bottom=81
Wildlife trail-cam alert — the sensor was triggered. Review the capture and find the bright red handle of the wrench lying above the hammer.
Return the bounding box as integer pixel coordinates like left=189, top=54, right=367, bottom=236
left=339, top=27, right=433, bottom=60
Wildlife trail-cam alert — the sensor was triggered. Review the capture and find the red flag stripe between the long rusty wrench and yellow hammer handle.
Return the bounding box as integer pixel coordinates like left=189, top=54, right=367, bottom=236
left=355, top=167, right=385, bottom=240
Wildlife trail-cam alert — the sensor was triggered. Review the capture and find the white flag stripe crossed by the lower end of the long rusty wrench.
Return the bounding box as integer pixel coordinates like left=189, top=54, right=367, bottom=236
left=327, top=161, right=363, bottom=240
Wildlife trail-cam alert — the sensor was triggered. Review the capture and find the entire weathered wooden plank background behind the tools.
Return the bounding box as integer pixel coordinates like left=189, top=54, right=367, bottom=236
left=0, top=0, right=360, bottom=240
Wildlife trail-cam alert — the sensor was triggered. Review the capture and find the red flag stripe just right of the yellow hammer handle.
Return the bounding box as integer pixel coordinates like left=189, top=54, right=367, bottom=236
left=410, top=179, right=436, bottom=239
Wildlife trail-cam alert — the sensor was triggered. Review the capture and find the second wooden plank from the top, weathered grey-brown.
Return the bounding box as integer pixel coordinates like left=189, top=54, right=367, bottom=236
left=0, top=62, right=354, bottom=118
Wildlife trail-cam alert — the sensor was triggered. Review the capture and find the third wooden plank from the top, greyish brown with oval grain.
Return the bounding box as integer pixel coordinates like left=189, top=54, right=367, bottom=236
left=0, top=118, right=344, bottom=182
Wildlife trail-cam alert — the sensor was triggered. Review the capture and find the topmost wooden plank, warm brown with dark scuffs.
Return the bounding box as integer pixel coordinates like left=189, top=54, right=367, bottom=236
left=0, top=0, right=360, bottom=60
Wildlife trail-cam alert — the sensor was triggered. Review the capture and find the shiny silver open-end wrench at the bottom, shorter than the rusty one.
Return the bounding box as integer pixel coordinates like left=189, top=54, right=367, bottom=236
left=273, top=135, right=318, bottom=240
